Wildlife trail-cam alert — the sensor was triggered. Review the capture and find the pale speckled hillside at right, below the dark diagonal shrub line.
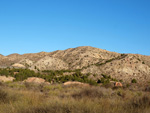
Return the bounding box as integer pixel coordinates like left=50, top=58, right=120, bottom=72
left=82, top=55, right=150, bottom=82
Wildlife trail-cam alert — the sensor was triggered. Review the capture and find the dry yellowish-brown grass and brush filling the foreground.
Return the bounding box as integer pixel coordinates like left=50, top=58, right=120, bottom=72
left=0, top=83, right=150, bottom=113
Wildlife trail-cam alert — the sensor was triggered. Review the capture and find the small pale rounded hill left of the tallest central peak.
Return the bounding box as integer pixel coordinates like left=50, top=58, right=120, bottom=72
left=31, top=56, right=68, bottom=70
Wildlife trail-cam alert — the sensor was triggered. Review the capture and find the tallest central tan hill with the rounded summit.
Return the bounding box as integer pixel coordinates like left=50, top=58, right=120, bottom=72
left=49, top=46, right=120, bottom=69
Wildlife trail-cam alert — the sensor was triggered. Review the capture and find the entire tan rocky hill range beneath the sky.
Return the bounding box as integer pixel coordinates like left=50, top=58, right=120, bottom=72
left=0, top=46, right=150, bottom=81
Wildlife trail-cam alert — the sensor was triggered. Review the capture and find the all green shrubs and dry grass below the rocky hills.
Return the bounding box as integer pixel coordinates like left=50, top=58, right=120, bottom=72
left=0, top=68, right=150, bottom=113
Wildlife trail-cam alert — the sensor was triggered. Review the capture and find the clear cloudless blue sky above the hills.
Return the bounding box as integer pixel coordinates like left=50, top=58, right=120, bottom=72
left=0, top=0, right=150, bottom=55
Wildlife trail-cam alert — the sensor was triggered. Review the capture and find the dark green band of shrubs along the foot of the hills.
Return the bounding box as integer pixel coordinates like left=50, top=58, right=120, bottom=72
left=0, top=68, right=97, bottom=85
